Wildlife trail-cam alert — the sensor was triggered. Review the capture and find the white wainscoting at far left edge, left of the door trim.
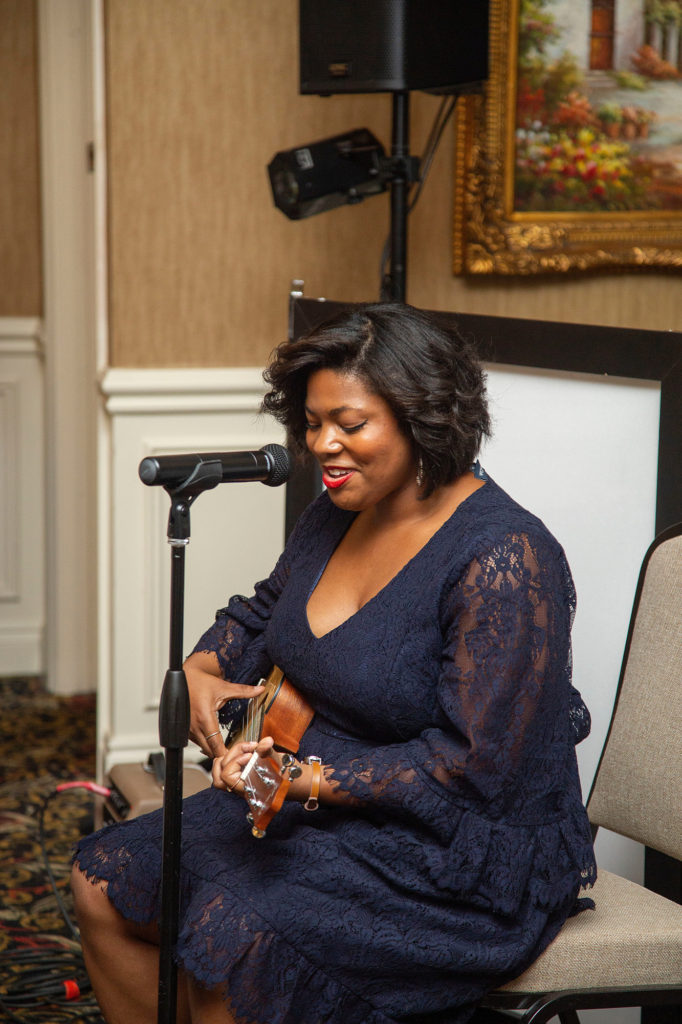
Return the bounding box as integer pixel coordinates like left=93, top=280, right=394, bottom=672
left=0, top=317, right=45, bottom=676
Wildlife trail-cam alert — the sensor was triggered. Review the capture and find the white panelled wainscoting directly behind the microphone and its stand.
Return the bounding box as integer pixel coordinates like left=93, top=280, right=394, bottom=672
left=98, top=369, right=285, bottom=771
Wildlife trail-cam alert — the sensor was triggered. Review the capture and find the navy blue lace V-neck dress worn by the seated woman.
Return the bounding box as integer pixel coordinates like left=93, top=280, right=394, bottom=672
left=77, top=480, right=595, bottom=1024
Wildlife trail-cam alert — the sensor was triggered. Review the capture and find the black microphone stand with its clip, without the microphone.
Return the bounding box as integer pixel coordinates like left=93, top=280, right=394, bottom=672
left=157, top=462, right=221, bottom=1024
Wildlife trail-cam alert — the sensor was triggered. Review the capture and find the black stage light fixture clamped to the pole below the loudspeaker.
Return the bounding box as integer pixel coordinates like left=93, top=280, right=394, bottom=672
left=267, top=128, right=391, bottom=220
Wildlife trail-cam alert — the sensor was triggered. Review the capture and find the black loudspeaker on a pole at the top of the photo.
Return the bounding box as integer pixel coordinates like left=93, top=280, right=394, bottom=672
left=299, top=0, right=488, bottom=95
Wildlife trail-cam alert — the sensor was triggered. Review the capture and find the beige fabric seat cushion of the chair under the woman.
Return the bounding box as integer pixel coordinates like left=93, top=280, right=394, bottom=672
left=493, top=869, right=682, bottom=992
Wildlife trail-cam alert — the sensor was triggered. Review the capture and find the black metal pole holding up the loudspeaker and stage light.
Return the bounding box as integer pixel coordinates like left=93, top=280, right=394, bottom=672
left=389, top=91, right=411, bottom=302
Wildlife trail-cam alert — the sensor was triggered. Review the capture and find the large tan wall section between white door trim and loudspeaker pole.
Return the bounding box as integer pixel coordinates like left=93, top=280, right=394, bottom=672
left=106, top=0, right=390, bottom=367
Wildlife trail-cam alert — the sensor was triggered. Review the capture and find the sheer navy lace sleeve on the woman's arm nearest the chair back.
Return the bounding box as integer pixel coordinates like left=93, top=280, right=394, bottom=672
left=333, top=534, right=574, bottom=820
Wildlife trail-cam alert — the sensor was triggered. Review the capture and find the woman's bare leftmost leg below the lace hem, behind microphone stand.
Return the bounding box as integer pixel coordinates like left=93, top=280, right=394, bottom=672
left=71, top=867, right=189, bottom=1024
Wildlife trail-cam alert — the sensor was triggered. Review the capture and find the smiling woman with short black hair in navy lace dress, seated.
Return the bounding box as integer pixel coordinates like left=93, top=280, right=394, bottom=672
left=74, top=304, right=595, bottom=1024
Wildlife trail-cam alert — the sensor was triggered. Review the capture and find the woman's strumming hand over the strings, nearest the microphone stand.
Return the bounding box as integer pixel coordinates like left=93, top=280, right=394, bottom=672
left=183, top=651, right=264, bottom=758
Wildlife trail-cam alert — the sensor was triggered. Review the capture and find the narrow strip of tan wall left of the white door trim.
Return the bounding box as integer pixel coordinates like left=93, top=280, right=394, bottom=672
left=0, top=0, right=42, bottom=316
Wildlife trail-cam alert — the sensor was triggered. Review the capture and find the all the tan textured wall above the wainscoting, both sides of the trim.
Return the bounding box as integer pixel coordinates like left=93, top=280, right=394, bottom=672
left=0, top=0, right=682, bottom=367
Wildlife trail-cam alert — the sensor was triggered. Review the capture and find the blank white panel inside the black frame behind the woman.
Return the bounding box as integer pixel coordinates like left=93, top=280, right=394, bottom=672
left=481, top=366, right=660, bottom=882
